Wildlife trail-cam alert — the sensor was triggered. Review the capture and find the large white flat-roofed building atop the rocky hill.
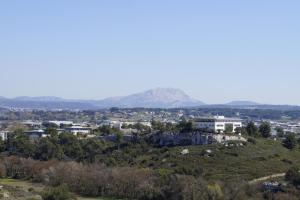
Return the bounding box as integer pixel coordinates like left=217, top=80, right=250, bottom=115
left=195, top=116, right=242, bottom=133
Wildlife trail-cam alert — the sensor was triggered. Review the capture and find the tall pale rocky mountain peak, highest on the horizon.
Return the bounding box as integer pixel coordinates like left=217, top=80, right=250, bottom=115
left=96, top=88, right=204, bottom=108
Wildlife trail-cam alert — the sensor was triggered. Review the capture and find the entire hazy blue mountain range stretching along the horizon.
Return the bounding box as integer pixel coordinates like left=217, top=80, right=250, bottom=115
left=0, top=88, right=300, bottom=110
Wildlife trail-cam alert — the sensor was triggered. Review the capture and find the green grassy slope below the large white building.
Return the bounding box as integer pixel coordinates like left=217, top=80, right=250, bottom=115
left=112, top=139, right=300, bottom=181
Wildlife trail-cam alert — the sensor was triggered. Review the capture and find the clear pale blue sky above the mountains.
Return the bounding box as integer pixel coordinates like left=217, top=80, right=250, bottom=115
left=0, top=0, right=300, bottom=105
